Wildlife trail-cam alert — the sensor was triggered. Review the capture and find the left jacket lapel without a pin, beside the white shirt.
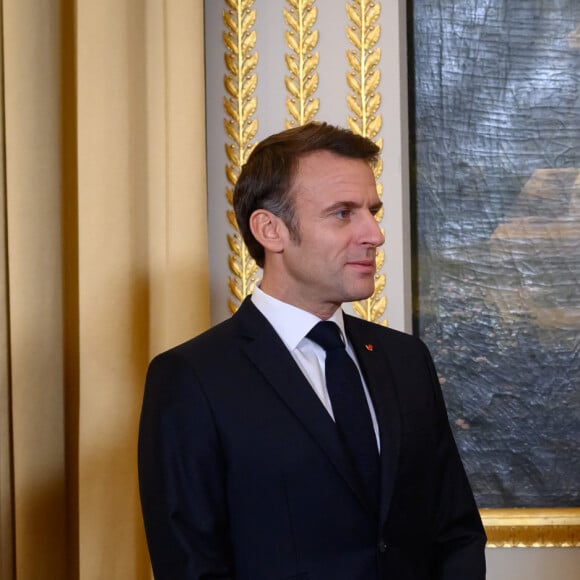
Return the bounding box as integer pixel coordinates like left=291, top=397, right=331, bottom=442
left=235, top=299, right=369, bottom=508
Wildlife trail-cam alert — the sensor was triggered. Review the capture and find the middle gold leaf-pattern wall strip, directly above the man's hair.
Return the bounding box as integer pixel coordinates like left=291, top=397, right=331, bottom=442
left=284, top=0, right=320, bottom=129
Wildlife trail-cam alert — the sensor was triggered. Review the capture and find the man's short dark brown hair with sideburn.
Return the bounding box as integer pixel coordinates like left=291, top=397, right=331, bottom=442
left=234, top=123, right=380, bottom=267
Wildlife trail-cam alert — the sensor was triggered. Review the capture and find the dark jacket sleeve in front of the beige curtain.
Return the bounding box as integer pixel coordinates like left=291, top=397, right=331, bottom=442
left=139, top=351, right=234, bottom=580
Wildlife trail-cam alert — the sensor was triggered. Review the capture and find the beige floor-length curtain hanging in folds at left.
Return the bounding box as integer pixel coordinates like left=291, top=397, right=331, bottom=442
left=0, top=0, right=209, bottom=580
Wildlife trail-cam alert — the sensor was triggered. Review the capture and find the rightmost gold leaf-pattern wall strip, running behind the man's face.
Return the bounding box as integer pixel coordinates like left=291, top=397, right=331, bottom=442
left=346, top=0, right=387, bottom=326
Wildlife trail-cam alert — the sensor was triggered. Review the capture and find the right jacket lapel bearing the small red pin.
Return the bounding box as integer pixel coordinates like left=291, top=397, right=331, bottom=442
left=345, top=316, right=401, bottom=523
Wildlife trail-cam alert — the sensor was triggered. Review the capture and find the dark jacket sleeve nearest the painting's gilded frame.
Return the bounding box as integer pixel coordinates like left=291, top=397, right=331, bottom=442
left=425, top=340, right=486, bottom=580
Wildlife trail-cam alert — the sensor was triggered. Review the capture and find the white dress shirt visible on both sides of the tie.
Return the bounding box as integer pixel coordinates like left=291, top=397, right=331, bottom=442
left=251, top=284, right=380, bottom=450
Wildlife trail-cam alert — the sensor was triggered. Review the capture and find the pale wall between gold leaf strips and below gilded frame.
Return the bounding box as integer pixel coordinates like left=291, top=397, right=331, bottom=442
left=205, top=0, right=580, bottom=580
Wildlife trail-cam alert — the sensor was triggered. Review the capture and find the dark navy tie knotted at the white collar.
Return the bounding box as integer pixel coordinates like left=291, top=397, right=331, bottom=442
left=307, top=321, right=379, bottom=504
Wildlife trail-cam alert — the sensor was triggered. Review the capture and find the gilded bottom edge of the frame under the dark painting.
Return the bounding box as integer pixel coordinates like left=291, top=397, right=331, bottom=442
left=480, top=508, right=580, bottom=548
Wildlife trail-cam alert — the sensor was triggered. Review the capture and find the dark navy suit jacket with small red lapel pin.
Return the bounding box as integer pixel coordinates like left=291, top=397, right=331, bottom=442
left=139, top=299, right=485, bottom=580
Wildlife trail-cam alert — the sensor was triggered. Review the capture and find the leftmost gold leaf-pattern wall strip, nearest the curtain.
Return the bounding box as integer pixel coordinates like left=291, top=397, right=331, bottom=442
left=223, top=0, right=258, bottom=313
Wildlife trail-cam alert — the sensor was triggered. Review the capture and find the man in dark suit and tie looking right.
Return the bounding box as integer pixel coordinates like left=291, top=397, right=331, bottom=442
left=139, top=123, right=485, bottom=580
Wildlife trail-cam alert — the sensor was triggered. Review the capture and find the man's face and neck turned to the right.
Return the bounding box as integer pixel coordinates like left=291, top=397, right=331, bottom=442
left=278, top=151, right=385, bottom=317
